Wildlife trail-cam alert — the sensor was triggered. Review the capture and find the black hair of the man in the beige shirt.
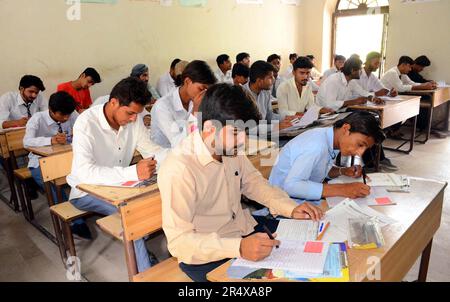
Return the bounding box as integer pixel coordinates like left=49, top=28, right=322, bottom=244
left=199, top=83, right=262, bottom=128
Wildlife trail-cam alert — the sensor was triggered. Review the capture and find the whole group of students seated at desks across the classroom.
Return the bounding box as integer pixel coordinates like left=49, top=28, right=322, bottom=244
left=0, top=49, right=436, bottom=281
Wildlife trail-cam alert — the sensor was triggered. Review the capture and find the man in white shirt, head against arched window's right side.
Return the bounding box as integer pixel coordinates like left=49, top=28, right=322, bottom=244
left=357, top=51, right=398, bottom=97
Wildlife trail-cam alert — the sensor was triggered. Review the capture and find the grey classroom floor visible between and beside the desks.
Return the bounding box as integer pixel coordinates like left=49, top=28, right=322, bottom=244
left=0, top=133, right=450, bottom=282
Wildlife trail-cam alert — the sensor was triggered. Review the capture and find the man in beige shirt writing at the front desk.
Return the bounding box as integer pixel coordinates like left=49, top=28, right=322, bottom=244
left=158, top=84, right=323, bottom=281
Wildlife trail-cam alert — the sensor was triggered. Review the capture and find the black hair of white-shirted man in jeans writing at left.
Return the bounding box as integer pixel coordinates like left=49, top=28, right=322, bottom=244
left=109, top=77, right=152, bottom=107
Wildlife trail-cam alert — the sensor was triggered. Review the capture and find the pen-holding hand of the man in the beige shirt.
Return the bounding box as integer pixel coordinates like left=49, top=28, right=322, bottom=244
left=239, top=233, right=280, bottom=261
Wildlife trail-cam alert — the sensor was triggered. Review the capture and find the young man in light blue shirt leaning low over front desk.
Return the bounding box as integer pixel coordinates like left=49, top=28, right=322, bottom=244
left=269, top=112, right=384, bottom=201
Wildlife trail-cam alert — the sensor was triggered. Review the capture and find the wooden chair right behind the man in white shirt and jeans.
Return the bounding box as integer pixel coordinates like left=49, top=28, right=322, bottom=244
left=39, top=152, right=89, bottom=266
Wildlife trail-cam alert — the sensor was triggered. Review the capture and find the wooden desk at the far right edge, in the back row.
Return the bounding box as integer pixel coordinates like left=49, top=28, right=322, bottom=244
left=402, top=87, right=450, bottom=144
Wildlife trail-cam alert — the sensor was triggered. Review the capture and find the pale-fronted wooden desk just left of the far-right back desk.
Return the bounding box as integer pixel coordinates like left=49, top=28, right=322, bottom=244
left=349, top=95, right=420, bottom=154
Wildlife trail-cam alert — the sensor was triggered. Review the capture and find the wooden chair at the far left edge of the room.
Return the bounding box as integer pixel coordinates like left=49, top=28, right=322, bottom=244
left=6, top=129, right=32, bottom=214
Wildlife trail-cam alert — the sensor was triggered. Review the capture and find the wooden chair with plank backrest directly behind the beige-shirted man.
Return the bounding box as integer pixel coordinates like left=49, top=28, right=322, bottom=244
left=119, top=192, right=192, bottom=282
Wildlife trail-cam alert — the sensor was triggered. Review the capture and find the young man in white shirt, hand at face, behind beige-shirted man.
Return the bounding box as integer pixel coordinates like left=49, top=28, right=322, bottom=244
left=151, top=61, right=216, bottom=148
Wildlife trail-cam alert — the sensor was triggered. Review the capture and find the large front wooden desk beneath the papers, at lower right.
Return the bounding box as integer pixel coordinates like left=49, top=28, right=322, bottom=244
left=207, top=178, right=447, bottom=282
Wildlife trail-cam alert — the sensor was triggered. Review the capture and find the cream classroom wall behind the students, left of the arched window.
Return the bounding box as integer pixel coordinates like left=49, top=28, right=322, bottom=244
left=0, top=0, right=303, bottom=97
